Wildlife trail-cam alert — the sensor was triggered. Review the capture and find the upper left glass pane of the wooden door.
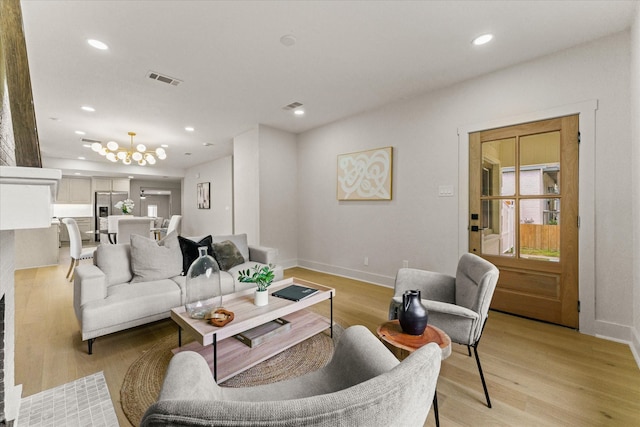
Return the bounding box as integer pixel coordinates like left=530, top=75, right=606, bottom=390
left=482, top=138, right=516, bottom=196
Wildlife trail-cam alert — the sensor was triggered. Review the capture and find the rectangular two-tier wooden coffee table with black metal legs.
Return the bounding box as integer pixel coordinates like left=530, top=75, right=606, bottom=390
left=171, top=278, right=336, bottom=382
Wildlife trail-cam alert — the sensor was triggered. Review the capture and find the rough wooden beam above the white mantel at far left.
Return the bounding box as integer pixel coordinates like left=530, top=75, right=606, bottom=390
left=0, top=0, right=42, bottom=167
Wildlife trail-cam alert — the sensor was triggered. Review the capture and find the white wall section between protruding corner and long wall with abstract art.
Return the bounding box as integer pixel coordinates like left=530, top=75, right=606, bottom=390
left=259, top=126, right=304, bottom=268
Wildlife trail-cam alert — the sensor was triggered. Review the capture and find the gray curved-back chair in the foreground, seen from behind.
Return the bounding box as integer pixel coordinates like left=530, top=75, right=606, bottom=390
left=140, top=326, right=441, bottom=427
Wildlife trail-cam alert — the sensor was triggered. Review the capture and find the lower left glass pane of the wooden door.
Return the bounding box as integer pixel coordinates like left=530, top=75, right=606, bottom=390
left=482, top=199, right=516, bottom=257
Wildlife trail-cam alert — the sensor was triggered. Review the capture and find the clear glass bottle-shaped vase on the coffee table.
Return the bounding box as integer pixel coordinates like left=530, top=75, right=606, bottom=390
left=184, top=246, right=222, bottom=319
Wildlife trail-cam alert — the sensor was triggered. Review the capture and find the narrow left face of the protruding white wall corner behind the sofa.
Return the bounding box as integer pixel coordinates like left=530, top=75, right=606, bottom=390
left=233, top=127, right=260, bottom=245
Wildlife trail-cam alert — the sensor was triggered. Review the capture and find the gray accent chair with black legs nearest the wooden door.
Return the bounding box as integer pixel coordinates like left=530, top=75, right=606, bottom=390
left=389, top=253, right=499, bottom=408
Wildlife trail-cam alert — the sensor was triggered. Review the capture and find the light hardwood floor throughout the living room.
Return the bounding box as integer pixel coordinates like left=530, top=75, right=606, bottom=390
left=15, top=248, right=640, bottom=427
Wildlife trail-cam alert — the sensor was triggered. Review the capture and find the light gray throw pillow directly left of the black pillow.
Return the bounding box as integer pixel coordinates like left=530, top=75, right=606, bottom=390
left=131, top=231, right=182, bottom=283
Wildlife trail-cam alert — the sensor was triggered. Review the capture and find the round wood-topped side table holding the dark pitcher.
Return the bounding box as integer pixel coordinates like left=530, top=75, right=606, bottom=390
left=378, top=320, right=451, bottom=427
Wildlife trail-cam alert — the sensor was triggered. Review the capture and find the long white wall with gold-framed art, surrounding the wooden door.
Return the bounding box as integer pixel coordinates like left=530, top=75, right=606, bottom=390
left=298, top=32, right=634, bottom=340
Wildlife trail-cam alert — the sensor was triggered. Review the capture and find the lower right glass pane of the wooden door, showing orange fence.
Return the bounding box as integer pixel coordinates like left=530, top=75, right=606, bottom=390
left=520, top=199, right=560, bottom=262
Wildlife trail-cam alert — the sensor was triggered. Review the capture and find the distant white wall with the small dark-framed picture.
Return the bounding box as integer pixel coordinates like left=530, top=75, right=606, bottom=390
left=182, top=156, right=233, bottom=236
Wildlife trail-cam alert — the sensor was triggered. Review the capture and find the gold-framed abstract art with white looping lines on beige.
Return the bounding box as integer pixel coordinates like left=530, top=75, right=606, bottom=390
left=337, top=147, right=393, bottom=200
